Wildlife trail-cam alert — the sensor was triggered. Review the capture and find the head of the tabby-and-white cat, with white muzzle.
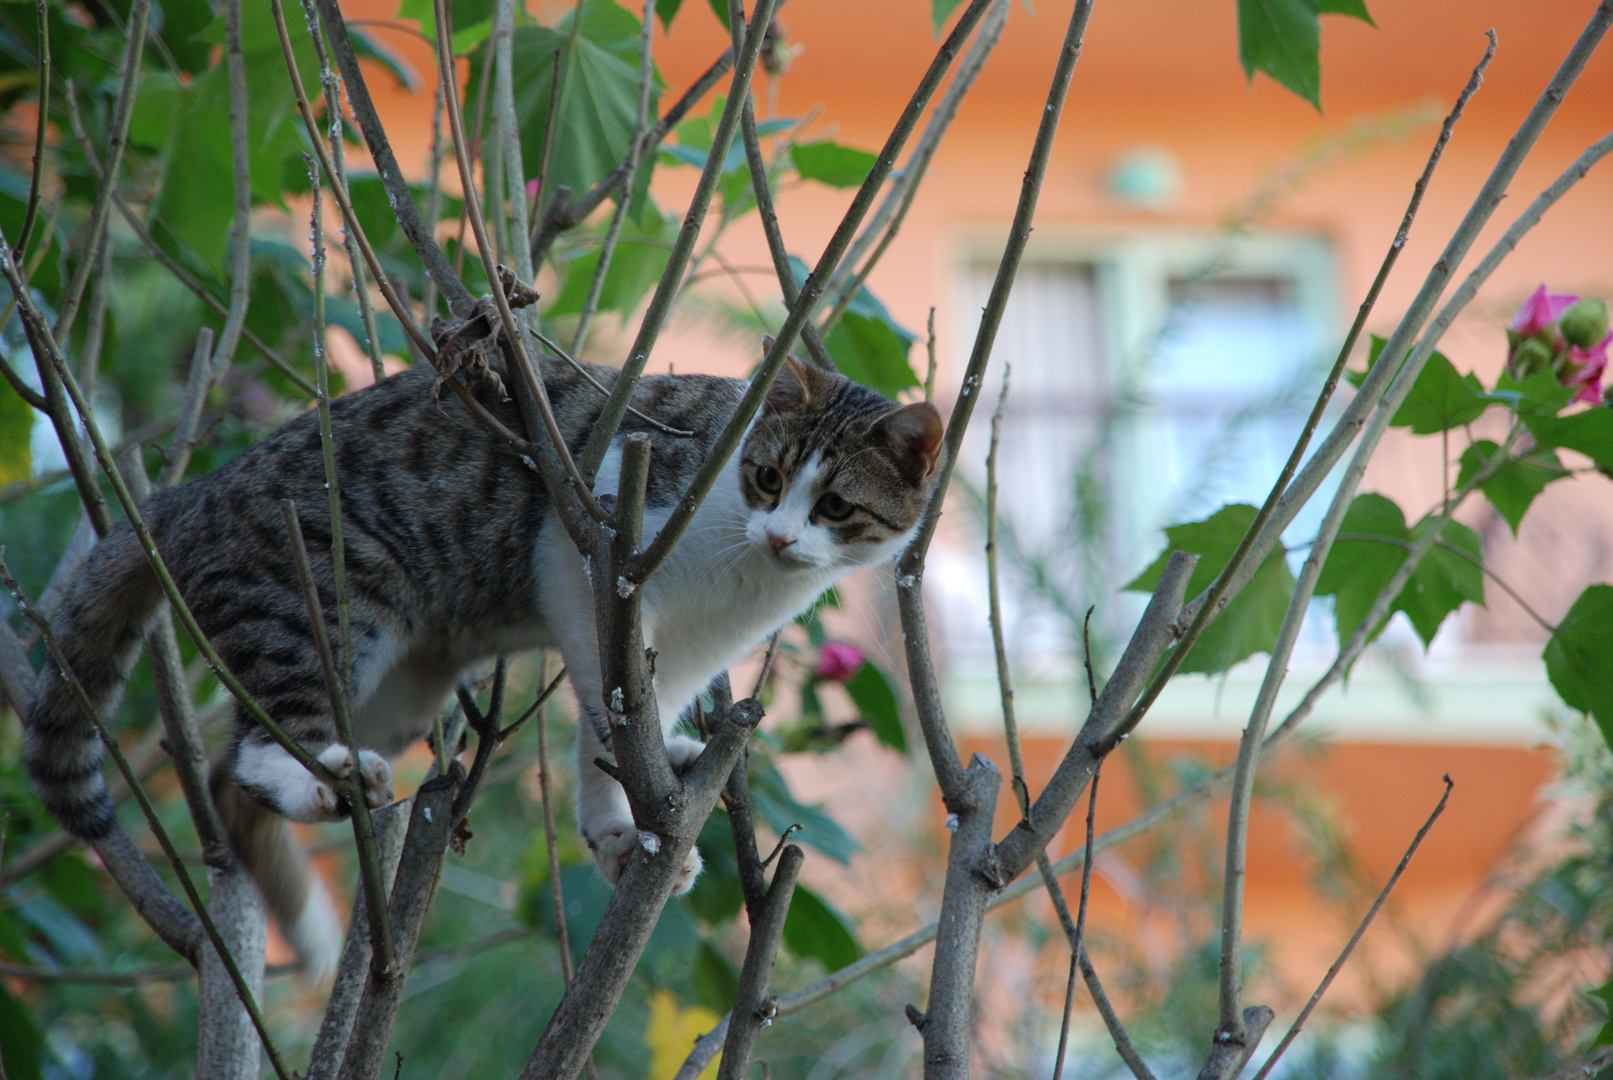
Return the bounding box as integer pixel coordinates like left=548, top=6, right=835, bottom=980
left=739, top=356, right=945, bottom=571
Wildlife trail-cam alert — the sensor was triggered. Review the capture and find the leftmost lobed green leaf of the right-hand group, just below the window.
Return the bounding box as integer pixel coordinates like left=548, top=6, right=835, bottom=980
left=1124, top=503, right=1294, bottom=674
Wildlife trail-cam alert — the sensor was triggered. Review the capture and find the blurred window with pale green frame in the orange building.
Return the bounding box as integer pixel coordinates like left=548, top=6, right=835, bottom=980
left=932, top=237, right=1336, bottom=667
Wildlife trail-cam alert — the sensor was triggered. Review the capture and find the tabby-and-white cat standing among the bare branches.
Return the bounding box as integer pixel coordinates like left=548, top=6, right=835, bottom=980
left=26, top=358, right=944, bottom=972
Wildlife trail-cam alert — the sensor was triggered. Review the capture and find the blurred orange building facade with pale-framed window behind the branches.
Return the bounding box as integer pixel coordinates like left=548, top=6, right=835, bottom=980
left=347, top=0, right=1613, bottom=1025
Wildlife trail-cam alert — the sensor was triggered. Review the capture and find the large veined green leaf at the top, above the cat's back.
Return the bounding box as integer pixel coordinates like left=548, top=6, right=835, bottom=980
left=465, top=0, right=660, bottom=207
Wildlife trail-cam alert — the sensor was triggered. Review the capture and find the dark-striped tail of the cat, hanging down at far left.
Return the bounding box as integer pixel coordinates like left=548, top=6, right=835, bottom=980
left=24, top=525, right=163, bottom=841
